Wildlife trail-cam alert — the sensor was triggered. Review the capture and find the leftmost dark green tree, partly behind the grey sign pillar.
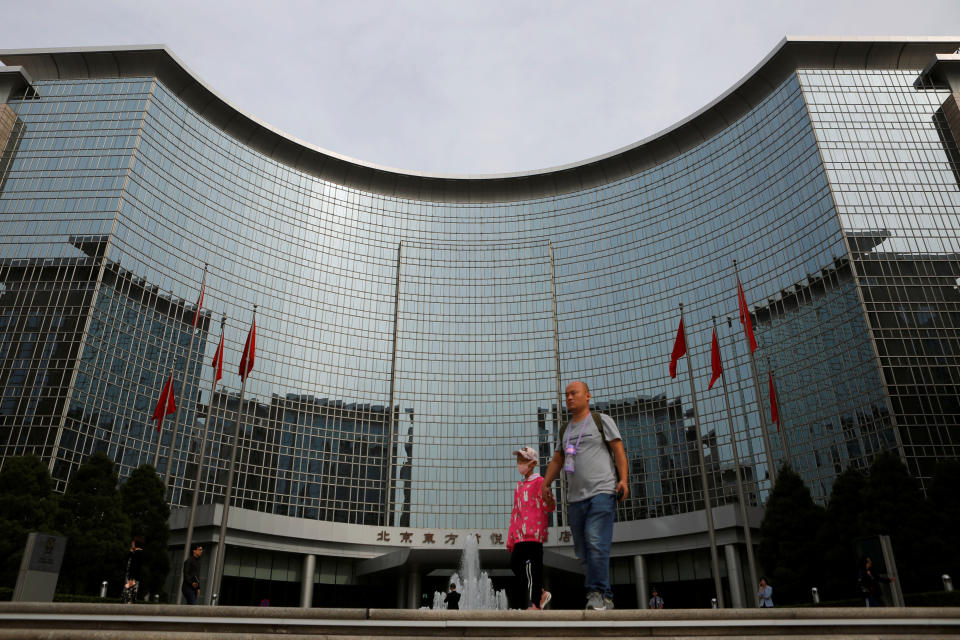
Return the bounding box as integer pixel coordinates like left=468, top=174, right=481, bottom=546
left=0, top=455, right=57, bottom=588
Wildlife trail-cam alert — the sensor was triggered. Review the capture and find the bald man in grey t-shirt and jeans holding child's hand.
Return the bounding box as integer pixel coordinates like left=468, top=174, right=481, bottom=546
left=543, top=380, right=629, bottom=610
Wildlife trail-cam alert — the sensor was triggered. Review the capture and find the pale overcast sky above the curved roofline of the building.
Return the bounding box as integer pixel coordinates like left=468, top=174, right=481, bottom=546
left=0, top=0, right=960, bottom=173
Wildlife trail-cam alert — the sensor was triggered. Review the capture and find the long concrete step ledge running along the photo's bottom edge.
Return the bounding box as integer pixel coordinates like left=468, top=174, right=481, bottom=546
left=0, top=602, right=960, bottom=640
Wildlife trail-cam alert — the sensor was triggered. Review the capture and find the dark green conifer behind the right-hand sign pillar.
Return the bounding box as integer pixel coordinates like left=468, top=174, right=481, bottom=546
left=862, top=451, right=943, bottom=592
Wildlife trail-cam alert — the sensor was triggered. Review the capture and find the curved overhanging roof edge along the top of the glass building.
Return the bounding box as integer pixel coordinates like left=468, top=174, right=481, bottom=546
left=0, top=36, right=960, bottom=202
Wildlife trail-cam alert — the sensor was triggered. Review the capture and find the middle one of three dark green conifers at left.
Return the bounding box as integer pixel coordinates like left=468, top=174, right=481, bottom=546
left=57, top=453, right=130, bottom=594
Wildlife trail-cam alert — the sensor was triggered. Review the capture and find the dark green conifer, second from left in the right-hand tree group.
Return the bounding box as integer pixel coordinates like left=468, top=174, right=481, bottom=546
left=818, top=467, right=868, bottom=600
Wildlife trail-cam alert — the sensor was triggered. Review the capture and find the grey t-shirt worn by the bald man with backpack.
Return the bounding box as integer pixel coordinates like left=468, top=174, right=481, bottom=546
left=557, top=413, right=621, bottom=502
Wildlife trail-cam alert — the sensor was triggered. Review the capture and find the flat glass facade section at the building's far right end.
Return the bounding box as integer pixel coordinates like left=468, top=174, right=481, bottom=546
left=799, top=70, right=960, bottom=482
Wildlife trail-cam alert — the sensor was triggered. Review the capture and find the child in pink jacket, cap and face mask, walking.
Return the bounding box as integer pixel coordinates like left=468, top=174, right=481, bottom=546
left=507, top=447, right=557, bottom=610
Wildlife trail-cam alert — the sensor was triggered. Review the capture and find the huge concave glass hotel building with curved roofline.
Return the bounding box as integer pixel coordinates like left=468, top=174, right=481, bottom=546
left=0, top=38, right=960, bottom=606
